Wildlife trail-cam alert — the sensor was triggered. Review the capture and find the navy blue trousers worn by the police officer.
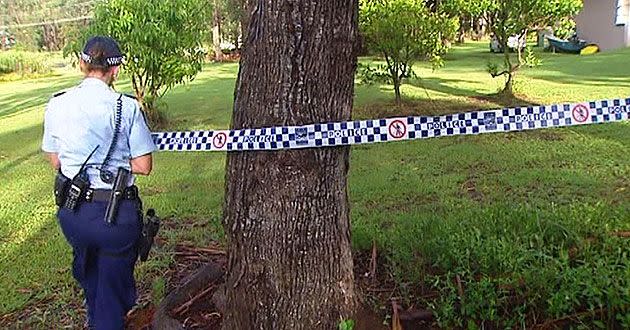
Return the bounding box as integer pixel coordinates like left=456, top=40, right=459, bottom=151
left=57, top=200, right=142, bottom=330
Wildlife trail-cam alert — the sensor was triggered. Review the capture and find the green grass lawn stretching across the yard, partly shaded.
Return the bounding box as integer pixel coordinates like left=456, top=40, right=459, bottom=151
left=0, top=43, right=630, bottom=327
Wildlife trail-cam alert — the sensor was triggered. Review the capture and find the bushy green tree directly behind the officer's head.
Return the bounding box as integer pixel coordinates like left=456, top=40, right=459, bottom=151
left=68, top=0, right=212, bottom=124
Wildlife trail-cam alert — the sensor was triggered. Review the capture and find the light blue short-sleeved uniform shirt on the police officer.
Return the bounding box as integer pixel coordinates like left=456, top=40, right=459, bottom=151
left=42, top=78, right=156, bottom=189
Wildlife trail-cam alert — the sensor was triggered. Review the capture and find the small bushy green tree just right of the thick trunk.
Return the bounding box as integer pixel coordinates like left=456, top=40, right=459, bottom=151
left=360, top=0, right=457, bottom=105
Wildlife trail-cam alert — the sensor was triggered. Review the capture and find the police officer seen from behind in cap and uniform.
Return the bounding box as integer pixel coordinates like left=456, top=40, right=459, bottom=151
left=42, top=36, right=156, bottom=330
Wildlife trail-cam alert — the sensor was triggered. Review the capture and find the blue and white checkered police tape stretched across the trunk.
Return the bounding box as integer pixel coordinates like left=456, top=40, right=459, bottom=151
left=152, top=98, right=630, bottom=151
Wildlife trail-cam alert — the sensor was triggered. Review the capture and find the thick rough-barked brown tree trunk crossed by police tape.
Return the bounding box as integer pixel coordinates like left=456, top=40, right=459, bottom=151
left=223, top=0, right=358, bottom=330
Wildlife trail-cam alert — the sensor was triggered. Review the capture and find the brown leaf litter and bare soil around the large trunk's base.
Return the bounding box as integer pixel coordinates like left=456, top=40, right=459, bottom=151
left=127, top=243, right=433, bottom=330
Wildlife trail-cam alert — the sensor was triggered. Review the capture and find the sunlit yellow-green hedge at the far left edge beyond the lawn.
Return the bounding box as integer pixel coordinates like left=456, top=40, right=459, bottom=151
left=0, top=50, right=51, bottom=75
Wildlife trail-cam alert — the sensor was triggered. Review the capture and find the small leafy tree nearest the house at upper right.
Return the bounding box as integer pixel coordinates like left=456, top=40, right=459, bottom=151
left=484, top=0, right=583, bottom=96
